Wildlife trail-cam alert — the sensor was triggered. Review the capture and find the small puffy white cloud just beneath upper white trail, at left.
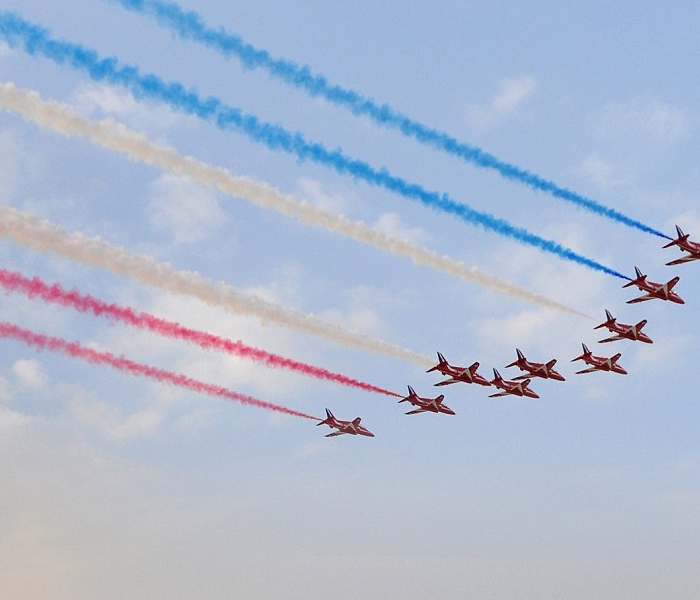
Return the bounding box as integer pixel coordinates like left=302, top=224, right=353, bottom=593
left=148, top=173, right=226, bottom=244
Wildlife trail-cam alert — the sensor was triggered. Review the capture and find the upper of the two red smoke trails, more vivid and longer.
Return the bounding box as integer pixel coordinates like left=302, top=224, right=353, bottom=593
left=0, top=269, right=399, bottom=397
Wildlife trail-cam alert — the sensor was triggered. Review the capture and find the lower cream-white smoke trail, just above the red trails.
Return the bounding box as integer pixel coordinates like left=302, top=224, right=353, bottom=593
left=0, top=206, right=434, bottom=365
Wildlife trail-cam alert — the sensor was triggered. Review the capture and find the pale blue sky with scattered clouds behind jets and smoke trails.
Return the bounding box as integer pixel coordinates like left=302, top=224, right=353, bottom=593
left=0, top=0, right=700, bottom=600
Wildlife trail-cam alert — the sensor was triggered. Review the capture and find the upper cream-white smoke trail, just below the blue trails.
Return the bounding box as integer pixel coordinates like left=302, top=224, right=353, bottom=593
left=0, top=83, right=590, bottom=318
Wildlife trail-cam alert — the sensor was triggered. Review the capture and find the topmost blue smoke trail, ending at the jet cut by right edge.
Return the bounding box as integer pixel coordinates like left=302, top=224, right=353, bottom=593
left=106, top=0, right=671, bottom=239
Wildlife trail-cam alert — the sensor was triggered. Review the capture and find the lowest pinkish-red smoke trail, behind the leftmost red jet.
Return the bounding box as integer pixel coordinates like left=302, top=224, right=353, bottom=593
left=0, top=322, right=320, bottom=421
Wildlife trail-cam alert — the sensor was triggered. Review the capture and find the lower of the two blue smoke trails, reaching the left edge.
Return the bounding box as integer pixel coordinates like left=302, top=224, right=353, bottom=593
left=0, top=11, right=629, bottom=279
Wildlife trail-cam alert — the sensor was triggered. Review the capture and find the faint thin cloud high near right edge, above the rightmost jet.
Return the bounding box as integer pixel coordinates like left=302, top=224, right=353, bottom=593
left=601, top=100, right=689, bottom=142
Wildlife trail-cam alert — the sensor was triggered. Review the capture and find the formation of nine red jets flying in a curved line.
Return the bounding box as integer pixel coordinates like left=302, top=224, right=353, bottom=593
left=318, top=225, right=700, bottom=437
